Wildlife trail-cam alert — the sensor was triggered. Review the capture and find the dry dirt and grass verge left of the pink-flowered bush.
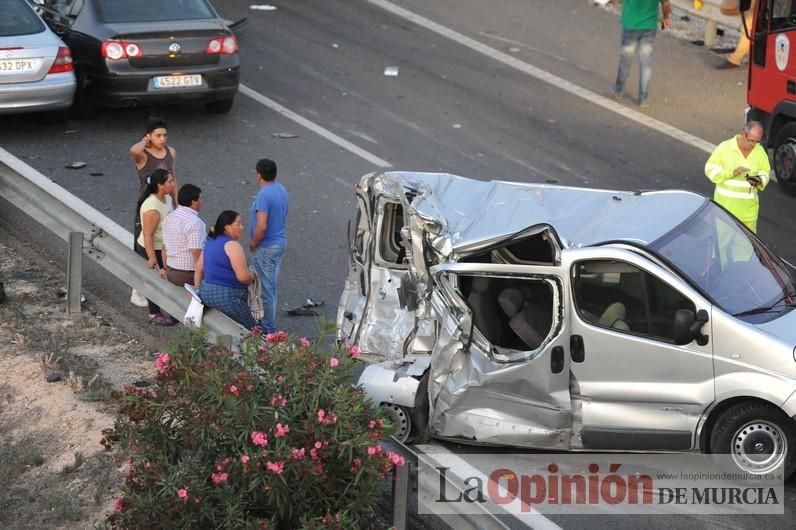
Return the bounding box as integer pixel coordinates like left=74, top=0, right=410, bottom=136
left=0, top=227, right=154, bottom=529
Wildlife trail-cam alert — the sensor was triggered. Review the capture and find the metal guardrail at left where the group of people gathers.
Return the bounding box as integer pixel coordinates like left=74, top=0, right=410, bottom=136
left=0, top=147, right=248, bottom=344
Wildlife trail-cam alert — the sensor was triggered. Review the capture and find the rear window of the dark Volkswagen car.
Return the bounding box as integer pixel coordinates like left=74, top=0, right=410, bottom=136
left=97, top=0, right=216, bottom=23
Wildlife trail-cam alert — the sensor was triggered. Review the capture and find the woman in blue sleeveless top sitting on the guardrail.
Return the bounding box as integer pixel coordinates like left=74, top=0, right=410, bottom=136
left=194, top=210, right=257, bottom=329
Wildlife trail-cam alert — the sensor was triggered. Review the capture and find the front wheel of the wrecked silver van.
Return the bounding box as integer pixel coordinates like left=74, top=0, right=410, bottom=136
left=710, top=403, right=796, bottom=479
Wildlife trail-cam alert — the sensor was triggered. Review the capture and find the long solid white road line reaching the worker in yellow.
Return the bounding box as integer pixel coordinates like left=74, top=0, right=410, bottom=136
left=365, top=0, right=716, bottom=153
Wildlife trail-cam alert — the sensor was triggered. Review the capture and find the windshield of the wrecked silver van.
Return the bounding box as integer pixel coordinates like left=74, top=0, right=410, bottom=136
left=650, top=203, right=794, bottom=319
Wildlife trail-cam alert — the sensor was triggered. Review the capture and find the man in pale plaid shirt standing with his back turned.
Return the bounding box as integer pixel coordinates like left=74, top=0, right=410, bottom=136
left=163, top=184, right=207, bottom=287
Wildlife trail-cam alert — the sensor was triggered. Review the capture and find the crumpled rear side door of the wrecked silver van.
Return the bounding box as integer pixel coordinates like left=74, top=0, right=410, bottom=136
left=428, top=263, right=571, bottom=449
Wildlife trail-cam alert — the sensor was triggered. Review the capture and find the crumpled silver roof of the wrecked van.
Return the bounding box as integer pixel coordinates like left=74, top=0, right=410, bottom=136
left=370, top=171, right=708, bottom=252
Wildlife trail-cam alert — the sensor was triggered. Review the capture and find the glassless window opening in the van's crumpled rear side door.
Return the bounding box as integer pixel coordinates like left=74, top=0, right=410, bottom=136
left=458, top=274, right=553, bottom=351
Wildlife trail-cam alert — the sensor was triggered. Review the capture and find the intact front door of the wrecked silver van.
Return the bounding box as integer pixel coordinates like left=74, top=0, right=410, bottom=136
left=564, top=248, right=714, bottom=450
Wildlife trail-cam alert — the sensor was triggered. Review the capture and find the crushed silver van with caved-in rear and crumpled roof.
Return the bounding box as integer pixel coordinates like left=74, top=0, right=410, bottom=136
left=337, top=172, right=796, bottom=475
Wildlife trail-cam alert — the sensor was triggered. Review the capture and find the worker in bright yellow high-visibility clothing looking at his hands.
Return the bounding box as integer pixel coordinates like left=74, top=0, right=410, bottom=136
left=705, top=121, right=771, bottom=232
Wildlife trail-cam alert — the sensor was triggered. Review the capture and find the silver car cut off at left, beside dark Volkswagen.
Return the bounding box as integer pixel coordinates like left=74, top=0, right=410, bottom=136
left=0, top=0, right=77, bottom=114
